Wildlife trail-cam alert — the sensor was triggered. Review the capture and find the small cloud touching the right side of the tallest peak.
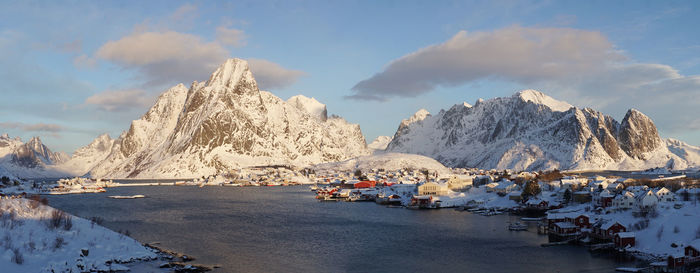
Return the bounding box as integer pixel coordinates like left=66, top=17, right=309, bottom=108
left=248, top=59, right=306, bottom=90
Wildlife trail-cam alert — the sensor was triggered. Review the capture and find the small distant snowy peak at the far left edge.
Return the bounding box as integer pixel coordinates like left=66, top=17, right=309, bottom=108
left=0, top=134, right=69, bottom=178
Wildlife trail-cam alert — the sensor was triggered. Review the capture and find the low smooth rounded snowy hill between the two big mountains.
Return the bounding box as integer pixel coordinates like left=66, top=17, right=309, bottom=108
left=313, top=153, right=450, bottom=174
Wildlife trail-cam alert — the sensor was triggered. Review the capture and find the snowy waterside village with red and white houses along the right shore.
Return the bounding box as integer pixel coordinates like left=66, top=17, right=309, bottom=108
left=311, top=168, right=700, bottom=272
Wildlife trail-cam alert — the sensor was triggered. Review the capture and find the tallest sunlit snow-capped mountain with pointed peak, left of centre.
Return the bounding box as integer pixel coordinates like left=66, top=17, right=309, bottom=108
left=89, top=59, right=369, bottom=178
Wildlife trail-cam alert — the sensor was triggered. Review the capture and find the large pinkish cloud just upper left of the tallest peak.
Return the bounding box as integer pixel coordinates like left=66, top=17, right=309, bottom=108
left=96, top=31, right=228, bottom=84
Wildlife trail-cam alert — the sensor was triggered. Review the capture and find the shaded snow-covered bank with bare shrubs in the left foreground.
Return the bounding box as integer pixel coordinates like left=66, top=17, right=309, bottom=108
left=0, top=197, right=158, bottom=272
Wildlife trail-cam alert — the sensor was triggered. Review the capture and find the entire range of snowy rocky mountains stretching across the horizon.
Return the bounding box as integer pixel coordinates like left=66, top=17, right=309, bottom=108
left=0, top=59, right=700, bottom=178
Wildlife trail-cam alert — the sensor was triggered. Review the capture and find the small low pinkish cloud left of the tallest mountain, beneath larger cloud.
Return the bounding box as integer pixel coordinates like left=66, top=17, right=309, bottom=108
left=85, top=89, right=154, bottom=112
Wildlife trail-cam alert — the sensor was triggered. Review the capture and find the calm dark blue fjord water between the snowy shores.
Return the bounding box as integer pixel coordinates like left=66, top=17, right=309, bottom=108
left=49, top=186, right=634, bottom=272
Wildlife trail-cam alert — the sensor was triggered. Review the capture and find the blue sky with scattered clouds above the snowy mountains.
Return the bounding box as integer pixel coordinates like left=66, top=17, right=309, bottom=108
left=0, top=0, right=700, bottom=154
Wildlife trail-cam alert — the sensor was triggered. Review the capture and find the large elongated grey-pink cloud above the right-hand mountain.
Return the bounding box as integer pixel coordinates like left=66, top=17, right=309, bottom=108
left=351, top=26, right=624, bottom=100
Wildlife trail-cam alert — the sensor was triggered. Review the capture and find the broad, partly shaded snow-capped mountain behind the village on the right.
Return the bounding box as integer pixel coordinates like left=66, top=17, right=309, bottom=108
left=386, top=90, right=700, bottom=170
